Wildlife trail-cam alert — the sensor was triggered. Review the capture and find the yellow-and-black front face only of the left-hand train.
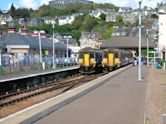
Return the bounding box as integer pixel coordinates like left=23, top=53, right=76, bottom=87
left=79, top=50, right=96, bottom=73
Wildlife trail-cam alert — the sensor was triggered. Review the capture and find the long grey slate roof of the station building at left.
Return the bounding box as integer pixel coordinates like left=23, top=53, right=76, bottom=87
left=0, top=33, right=66, bottom=50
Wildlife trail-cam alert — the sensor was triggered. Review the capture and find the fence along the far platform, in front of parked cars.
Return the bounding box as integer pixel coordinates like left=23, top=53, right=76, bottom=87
left=1, top=54, right=76, bottom=74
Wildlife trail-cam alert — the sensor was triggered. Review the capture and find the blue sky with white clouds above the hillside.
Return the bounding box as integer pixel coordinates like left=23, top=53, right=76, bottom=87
left=0, top=0, right=166, bottom=10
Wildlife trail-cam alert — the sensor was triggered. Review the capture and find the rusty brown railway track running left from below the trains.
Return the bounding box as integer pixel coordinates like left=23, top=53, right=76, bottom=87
left=0, top=74, right=103, bottom=108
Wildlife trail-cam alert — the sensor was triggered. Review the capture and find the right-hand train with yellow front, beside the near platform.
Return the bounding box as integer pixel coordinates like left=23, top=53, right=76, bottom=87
left=102, top=49, right=132, bottom=72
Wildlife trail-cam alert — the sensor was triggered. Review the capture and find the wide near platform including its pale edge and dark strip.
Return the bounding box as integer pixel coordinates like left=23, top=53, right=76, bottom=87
left=0, top=66, right=149, bottom=124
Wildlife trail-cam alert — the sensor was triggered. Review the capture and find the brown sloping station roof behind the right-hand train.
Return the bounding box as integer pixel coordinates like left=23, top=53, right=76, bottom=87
left=101, top=36, right=155, bottom=48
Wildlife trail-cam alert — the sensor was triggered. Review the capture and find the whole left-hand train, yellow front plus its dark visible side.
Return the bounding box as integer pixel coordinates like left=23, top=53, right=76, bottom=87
left=79, top=48, right=102, bottom=73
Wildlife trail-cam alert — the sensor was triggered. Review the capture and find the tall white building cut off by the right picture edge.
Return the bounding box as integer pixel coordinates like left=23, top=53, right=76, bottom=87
left=158, top=4, right=166, bottom=59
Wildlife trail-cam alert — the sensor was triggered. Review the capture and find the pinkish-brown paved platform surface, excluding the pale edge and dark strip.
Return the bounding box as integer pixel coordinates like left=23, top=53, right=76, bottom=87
left=32, top=66, right=149, bottom=124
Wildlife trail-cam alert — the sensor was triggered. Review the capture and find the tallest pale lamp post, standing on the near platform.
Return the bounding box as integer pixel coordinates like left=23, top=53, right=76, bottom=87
left=138, top=0, right=142, bottom=81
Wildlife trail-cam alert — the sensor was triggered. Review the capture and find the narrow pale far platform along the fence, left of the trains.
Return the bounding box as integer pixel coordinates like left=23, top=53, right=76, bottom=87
left=0, top=66, right=79, bottom=83
